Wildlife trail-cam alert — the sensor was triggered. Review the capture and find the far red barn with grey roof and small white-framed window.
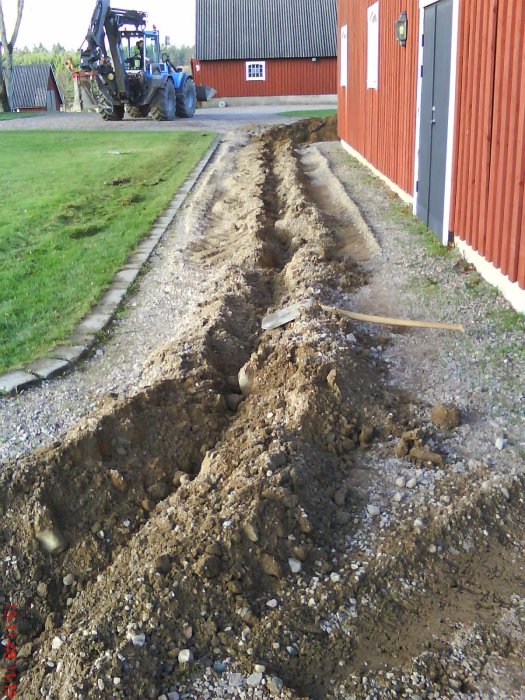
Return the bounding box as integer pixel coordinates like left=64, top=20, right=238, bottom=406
left=194, top=0, right=337, bottom=97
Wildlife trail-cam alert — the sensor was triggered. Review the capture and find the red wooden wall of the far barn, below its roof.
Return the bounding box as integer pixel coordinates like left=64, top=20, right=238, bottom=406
left=197, top=58, right=337, bottom=97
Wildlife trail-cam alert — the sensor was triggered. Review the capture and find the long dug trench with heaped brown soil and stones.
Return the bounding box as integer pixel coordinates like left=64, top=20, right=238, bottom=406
left=0, top=123, right=525, bottom=700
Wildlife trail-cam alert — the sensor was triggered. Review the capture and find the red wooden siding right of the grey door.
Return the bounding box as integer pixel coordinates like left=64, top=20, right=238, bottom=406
left=451, top=0, right=525, bottom=288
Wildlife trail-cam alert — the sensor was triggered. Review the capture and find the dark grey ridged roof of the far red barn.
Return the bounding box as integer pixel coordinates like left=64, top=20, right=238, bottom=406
left=196, top=0, right=337, bottom=61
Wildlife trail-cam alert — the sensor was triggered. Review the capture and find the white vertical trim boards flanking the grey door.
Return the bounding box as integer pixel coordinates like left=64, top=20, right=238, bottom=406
left=413, top=0, right=459, bottom=245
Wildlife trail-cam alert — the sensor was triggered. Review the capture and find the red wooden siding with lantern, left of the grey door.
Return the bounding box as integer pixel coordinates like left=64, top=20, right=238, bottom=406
left=337, top=0, right=419, bottom=194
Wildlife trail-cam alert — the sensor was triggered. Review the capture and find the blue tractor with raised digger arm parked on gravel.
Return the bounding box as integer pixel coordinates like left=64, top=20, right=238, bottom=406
left=80, top=0, right=213, bottom=121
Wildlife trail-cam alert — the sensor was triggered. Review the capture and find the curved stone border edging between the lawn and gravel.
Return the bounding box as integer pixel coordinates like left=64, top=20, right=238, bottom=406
left=0, top=135, right=222, bottom=395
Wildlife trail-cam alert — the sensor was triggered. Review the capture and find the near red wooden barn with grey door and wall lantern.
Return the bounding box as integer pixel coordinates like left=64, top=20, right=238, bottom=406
left=338, top=0, right=525, bottom=311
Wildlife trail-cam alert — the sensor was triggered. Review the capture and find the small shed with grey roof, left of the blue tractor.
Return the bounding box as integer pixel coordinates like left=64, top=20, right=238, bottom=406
left=11, top=63, right=64, bottom=112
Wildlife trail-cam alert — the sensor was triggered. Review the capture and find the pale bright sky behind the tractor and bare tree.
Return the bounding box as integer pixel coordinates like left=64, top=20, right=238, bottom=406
left=1, top=0, right=195, bottom=50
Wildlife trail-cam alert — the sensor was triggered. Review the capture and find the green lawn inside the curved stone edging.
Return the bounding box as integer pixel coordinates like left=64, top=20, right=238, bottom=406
left=0, top=131, right=214, bottom=372
